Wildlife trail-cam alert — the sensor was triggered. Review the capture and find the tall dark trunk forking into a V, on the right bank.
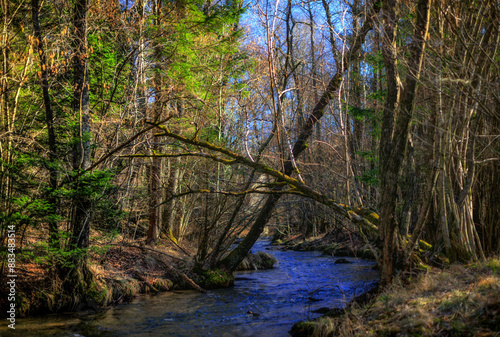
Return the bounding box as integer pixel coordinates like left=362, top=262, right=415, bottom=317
left=379, top=0, right=430, bottom=284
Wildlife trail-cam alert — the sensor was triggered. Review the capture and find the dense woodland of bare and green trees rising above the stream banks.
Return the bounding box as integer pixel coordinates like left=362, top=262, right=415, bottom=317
left=0, top=0, right=500, bottom=316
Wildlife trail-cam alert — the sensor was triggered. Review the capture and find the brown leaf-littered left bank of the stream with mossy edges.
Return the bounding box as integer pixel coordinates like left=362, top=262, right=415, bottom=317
left=0, top=238, right=276, bottom=318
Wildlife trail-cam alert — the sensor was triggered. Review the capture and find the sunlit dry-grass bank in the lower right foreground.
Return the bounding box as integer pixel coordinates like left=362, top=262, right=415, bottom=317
left=291, top=258, right=500, bottom=337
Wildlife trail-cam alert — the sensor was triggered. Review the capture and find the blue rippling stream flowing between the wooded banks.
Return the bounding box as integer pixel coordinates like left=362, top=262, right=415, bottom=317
left=0, top=240, right=377, bottom=337
